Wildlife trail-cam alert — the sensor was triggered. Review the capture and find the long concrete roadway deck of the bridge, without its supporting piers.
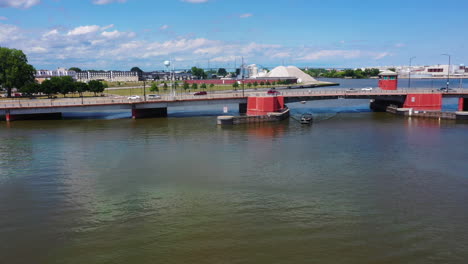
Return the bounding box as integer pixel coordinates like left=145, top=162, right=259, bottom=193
left=0, top=88, right=468, bottom=121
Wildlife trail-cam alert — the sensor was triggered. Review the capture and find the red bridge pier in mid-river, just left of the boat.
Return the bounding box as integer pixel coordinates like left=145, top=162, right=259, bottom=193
left=247, top=96, right=285, bottom=116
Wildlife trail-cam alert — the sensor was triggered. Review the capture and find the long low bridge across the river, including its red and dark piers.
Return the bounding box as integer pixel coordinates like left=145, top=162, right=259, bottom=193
left=0, top=88, right=468, bottom=121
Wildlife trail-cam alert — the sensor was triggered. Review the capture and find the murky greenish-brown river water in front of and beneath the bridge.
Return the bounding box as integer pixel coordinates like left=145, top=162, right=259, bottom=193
left=0, top=78, right=468, bottom=263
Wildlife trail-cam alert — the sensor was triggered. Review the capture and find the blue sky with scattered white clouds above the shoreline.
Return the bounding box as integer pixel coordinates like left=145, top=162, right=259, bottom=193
left=0, top=0, right=468, bottom=71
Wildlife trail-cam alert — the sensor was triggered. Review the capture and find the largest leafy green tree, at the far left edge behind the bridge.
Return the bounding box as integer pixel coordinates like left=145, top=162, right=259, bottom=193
left=0, top=47, right=36, bottom=97
